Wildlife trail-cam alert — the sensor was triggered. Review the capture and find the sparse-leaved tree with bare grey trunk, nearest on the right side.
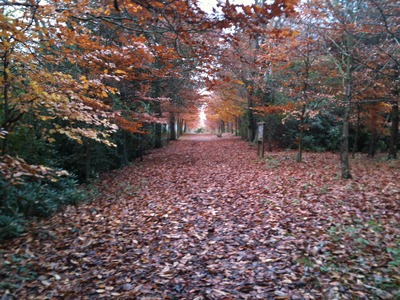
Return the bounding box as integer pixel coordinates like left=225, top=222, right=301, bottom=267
left=314, top=0, right=396, bottom=179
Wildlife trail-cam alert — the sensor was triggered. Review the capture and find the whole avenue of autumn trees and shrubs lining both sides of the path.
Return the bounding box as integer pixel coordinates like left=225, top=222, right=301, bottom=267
left=0, top=0, right=400, bottom=237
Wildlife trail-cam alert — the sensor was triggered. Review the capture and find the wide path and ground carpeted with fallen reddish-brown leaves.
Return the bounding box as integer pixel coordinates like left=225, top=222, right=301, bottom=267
left=0, top=135, right=400, bottom=300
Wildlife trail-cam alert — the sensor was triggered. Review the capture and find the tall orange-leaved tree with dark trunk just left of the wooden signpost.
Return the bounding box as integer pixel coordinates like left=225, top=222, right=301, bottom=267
left=203, top=1, right=298, bottom=141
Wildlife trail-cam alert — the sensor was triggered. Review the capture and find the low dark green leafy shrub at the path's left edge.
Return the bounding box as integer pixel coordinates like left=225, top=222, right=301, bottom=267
left=0, top=177, right=85, bottom=241
